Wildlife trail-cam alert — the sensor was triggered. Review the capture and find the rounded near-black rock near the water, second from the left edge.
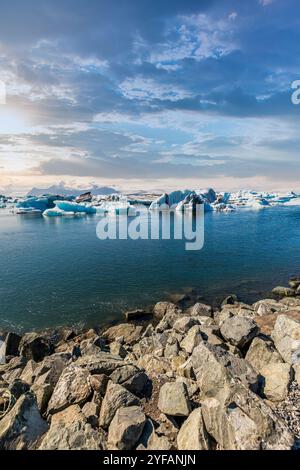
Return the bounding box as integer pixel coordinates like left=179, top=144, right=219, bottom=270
left=19, top=333, right=54, bottom=362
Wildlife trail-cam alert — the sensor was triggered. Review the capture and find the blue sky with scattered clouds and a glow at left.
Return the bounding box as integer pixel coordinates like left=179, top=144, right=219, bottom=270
left=0, top=0, right=300, bottom=191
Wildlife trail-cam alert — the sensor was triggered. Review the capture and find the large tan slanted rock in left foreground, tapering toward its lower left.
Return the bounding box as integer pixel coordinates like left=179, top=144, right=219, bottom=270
left=48, top=364, right=92, bottom=414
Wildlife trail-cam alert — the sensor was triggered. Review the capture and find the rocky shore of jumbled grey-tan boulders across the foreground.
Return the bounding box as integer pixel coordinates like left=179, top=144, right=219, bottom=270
left=0, top=278, right=300, bottom=450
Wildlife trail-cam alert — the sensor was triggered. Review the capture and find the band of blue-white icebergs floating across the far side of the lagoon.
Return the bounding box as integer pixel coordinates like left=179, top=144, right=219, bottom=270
left=0, top=188, right=300, bottom=217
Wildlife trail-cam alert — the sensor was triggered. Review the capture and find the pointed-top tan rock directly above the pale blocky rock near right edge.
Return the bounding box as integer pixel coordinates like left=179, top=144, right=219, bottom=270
left=245, top=337, right=283, bottom=372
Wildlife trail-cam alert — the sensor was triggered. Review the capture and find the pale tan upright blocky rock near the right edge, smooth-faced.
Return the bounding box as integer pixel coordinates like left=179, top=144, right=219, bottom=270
left=260, top=363, right=292, bottom=402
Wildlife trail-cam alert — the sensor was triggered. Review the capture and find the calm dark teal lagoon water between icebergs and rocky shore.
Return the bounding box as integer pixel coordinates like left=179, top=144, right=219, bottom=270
left=0, top=207, right=300, bottom=330
